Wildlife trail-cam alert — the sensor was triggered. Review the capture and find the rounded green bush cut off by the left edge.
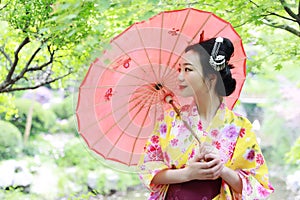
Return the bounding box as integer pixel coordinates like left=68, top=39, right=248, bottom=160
left=0, top=120, right=22, bottom=160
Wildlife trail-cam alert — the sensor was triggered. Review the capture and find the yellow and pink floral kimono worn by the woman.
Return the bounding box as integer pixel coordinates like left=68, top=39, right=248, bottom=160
left=138, top=103, right=274, bottom=200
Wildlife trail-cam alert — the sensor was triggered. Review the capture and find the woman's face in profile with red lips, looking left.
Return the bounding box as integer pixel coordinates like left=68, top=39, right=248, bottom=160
left=178, top=50, right=208, bottom=97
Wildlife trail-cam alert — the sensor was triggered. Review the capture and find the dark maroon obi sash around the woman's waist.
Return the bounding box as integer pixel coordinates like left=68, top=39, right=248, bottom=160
left=165, top=178, right=222, bottom=200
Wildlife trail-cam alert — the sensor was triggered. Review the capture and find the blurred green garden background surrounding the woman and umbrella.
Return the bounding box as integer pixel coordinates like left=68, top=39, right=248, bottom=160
left=0, top=0, right=300, bottom=200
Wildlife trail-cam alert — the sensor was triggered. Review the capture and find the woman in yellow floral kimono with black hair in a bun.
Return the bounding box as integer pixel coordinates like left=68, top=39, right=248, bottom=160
left=139, top=38, right=273, bottom=200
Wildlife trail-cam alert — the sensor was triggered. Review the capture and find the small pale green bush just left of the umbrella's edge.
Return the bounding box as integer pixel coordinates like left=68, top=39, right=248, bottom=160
left=51, top=95, right=76, bottom=119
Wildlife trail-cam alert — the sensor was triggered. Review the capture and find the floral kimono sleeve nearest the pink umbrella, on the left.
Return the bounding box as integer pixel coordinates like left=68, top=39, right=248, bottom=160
left=138, top=119, right=169, bottom=193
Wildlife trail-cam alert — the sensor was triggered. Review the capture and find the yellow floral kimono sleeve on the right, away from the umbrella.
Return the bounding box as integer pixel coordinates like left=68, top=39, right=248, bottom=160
left=229, top=120, right=274, bottom=199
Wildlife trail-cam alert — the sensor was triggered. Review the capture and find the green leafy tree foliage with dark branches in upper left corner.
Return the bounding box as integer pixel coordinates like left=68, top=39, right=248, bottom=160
left=0, top=0, right=105, bottom=92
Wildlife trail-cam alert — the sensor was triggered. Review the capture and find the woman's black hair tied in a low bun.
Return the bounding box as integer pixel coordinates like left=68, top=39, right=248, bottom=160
left=185, top=38, right=236, bottom=96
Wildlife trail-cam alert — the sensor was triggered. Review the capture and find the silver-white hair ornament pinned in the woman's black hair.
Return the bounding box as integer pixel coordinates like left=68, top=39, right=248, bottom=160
left=209, top=37, right=226, bottom=71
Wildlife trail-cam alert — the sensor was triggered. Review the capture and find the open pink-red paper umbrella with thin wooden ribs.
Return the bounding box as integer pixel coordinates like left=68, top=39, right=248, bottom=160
left=76, top=8, right=246, bottom=165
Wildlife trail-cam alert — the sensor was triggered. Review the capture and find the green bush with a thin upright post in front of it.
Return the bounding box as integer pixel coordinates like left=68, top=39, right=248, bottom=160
left=10, top=99, right=56, bottom=134
